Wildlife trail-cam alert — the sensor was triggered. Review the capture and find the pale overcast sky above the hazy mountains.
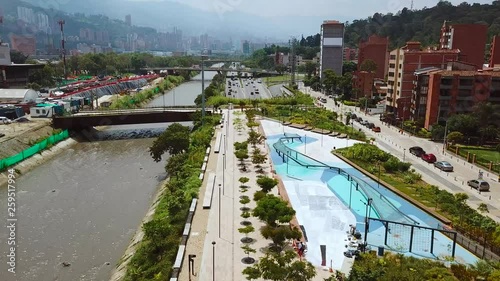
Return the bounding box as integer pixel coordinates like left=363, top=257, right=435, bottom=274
left=170, top=0, right=492, bottom=20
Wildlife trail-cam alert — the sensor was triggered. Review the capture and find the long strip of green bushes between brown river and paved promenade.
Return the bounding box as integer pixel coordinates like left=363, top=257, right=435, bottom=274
left=124, top=116, right=220, bottom=281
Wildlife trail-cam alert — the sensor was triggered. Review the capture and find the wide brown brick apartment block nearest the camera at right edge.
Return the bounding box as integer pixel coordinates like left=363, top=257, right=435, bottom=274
left=424, top=70, right=500, bottom=129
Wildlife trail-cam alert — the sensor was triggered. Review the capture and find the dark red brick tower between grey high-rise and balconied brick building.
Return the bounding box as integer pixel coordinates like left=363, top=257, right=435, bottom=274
left=358, top=35, right=389, bottom=79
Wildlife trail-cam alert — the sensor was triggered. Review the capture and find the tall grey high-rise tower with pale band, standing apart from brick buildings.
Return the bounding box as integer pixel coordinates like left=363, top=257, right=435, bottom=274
left=319, top=20, right=344, bottom=79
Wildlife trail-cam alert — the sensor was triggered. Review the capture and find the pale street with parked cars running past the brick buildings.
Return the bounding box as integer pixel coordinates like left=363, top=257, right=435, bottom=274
left=302, top=88, right=500, bottom=223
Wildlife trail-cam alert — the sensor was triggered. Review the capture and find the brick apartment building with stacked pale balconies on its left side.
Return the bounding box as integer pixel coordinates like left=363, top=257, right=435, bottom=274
left=386, top=42, right=460, bottom=119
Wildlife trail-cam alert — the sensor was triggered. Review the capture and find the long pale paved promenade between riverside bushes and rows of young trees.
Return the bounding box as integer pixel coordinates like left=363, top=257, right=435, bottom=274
left=179, top=110, right=336, bottom=281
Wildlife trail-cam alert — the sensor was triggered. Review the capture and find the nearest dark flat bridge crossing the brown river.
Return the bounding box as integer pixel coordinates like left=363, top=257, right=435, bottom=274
left=52, top=108, right=212, bottom=130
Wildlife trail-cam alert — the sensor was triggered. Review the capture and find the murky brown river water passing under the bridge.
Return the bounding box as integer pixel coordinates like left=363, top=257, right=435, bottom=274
left=0, top=69, right=219, bottom=281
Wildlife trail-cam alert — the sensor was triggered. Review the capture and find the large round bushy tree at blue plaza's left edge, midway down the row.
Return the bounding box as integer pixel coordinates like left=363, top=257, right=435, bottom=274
left=253, top=194, right=295, bottom=227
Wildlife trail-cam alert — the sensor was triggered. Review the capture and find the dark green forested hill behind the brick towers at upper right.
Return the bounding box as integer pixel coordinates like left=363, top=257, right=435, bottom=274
left=345, top=0, right=500, bottom=49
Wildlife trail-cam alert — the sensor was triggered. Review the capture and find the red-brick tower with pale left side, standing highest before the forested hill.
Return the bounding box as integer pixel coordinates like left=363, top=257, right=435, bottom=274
left=439, top=21, right=488, bottom=69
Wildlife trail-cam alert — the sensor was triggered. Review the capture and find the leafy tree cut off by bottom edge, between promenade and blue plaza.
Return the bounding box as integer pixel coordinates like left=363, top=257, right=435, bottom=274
left=243, top=251, right=316, bottom=281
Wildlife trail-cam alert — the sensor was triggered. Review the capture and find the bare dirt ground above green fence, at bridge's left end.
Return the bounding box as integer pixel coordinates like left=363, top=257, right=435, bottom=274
left=0, top=116, right=53, bottom=159
